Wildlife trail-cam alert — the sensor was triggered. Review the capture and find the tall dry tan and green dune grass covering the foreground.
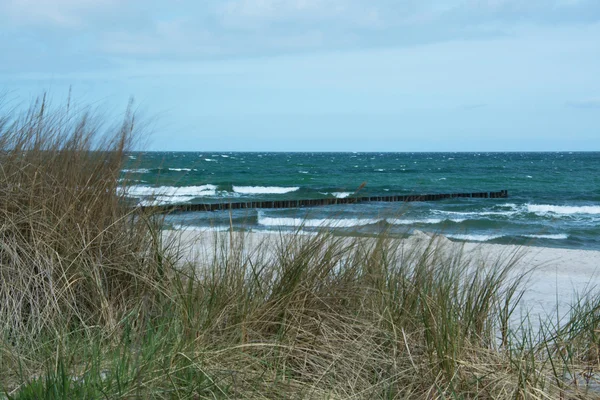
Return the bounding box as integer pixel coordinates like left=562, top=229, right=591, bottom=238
left=0, top=96, right=600, bottom=399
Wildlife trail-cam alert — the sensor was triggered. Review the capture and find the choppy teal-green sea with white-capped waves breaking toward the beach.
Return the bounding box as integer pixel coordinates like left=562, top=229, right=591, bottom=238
left=121, top=152, right=600, bottom=250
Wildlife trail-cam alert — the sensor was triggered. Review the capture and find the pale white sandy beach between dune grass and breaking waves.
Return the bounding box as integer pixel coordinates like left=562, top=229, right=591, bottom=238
left=165, top=230, right=600, bottom=323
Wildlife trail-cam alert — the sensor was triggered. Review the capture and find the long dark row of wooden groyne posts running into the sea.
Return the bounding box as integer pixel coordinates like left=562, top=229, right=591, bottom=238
left=142, top=190, right=508, bottom=212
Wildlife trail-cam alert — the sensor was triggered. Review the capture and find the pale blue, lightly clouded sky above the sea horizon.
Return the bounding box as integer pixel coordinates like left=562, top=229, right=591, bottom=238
left=0, top=0, right=600, bottom=151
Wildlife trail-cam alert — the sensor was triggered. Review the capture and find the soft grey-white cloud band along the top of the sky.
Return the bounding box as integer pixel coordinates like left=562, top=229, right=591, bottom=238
left=0, top=0, right=600, bottom=71
